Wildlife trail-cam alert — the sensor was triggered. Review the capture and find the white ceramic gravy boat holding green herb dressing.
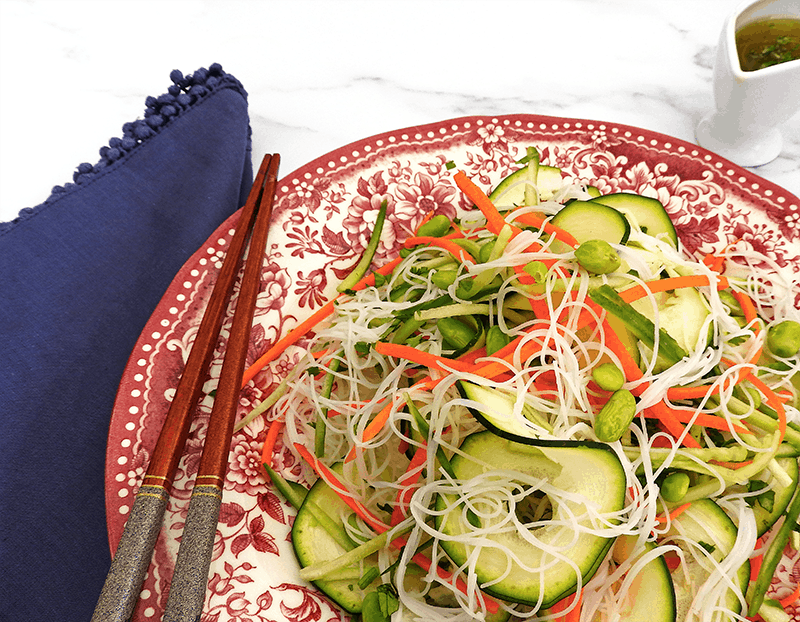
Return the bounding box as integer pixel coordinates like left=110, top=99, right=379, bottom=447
left=696, top=0, right=800, bottom=166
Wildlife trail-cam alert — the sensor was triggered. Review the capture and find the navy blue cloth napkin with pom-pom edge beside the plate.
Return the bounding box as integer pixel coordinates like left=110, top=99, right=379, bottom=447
left=0, top=65, right=252, bottom=621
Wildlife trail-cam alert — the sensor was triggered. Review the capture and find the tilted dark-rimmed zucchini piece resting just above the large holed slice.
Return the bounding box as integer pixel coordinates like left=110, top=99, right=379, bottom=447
left=457, top=380, right=552, bottom=443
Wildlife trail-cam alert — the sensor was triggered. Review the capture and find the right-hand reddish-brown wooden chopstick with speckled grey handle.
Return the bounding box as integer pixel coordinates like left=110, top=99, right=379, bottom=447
left=162, top=155, right=280, bottom=622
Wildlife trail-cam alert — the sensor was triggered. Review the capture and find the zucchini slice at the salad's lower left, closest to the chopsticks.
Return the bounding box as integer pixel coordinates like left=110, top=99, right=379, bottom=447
left=292, top=465, right=380, bottom=613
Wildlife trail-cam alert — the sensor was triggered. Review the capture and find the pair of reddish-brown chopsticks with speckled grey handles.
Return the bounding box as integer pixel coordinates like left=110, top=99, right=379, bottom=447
left=92, top=154, right=280, bottom=622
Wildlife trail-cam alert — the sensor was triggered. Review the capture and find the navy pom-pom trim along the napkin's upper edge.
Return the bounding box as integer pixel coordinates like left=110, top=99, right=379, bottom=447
left=0, top=63, right=251, bottom=234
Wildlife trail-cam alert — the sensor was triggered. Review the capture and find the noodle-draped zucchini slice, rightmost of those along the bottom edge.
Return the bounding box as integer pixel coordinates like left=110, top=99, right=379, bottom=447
left=668, top=499, right=750, bottom=622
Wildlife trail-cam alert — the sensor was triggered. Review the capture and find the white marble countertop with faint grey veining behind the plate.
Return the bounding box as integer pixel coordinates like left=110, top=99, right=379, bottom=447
left=0, top=0, right=800, bottom=221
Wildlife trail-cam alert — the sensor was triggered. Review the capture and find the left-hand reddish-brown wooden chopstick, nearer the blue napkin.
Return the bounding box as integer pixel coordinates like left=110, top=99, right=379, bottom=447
left=92, top=156, right=274, bottom=622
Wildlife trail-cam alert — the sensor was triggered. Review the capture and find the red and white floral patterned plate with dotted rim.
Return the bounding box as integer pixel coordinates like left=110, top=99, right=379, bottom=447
left=106, top=115, right=800, bottom=622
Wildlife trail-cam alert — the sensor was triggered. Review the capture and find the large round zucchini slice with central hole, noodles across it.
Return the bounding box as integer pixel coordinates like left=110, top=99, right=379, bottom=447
left=436, top=431, right=626, bottom=608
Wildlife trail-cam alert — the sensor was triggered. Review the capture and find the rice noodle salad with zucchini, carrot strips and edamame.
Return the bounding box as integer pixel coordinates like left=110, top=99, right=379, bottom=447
left=247, top=149, right=800, bottom=622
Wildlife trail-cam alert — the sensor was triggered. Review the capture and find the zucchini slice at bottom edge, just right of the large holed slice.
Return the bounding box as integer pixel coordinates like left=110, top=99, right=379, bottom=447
left=593, top=536, right=677, bottom=622
